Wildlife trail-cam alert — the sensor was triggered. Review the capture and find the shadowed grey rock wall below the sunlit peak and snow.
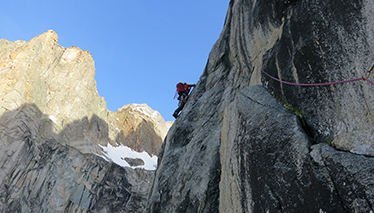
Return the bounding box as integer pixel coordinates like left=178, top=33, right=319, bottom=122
left=0, top=104, right=153, bottom=212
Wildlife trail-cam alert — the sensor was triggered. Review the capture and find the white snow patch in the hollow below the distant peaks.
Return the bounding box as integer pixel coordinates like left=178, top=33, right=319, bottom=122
left=99, top=144, right=157, bottom=170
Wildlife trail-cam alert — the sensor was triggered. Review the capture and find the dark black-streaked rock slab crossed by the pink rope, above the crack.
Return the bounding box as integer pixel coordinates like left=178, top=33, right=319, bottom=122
left=262, top=1, right=374, bottom=148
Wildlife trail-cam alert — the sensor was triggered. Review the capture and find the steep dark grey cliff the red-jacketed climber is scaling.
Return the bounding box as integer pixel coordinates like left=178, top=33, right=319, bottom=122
left=147, top=0, right=374, bottom=212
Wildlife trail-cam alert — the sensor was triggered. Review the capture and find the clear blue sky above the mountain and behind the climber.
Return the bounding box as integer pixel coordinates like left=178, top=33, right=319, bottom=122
left=0, top=0, right=229, bottom=120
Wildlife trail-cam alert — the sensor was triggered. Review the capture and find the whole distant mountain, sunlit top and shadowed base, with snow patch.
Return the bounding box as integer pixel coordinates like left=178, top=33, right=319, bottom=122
left=0, top=30, right=167, bottom=212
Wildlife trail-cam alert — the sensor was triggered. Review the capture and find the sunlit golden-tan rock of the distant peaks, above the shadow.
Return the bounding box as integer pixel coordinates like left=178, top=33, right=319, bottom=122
left=0, top=30, right=167, bottom=154
